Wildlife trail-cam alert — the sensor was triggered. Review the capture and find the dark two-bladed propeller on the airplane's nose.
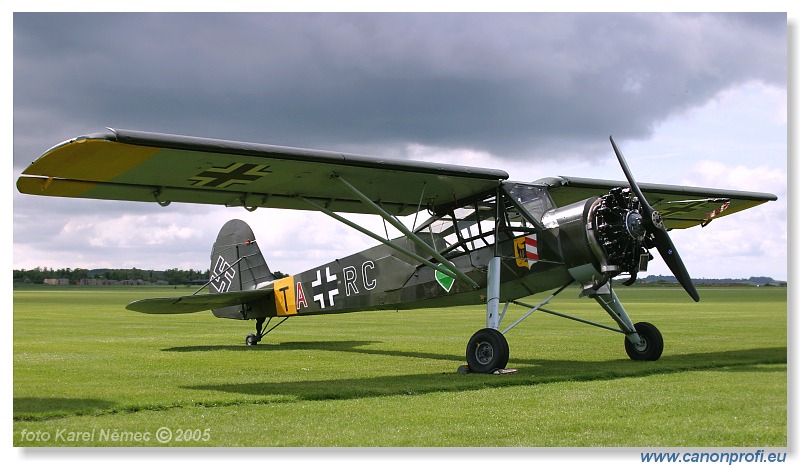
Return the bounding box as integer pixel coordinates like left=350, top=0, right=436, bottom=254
left=609, top=137, right=700, bottom=301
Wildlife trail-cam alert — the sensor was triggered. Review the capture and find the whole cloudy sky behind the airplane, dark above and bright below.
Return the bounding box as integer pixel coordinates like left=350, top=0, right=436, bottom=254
left=12, top=13, right=788, bottom=279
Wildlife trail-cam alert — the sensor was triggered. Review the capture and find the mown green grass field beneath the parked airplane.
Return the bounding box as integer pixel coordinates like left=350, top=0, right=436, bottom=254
left=13, top=287, right=788, bottom=447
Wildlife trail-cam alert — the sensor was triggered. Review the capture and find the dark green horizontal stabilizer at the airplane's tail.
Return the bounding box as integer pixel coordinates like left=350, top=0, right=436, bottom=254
left=125, top=288, right=273, bottom=314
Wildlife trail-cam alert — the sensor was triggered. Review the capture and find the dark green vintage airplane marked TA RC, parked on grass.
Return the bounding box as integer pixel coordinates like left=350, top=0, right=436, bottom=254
left=17, top=128, right=777, bottom=373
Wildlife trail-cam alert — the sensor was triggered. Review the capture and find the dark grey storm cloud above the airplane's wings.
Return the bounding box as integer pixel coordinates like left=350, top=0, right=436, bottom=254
left=14, top=13, right=787, bottom=165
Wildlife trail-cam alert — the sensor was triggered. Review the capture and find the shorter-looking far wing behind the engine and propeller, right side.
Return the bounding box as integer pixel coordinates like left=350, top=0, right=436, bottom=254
left=536, top=176, right=777, bottom=229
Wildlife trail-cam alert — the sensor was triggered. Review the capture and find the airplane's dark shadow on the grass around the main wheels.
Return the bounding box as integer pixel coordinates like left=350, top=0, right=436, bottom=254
left=178, top=341, right=787, bottom=401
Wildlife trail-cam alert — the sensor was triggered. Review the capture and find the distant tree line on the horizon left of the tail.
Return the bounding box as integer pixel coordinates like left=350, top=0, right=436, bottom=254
left=14, top=267, right=209, bottom=285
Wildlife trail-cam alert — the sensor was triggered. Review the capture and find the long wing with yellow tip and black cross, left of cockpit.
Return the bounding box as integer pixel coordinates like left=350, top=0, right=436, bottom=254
left=17, top=129, right=508, bottom=216
